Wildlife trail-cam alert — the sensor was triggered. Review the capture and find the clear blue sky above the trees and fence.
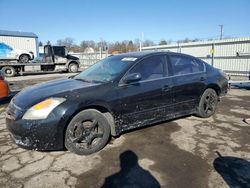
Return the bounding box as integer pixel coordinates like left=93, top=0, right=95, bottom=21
left=0, top=0, right=250, bottom=44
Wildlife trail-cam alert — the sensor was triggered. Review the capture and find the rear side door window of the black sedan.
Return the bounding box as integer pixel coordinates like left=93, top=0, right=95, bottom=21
left=170, top=55, right=204, bottom=75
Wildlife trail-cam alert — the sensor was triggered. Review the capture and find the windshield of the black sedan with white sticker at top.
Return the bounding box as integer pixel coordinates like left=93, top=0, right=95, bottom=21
left=74, top=56, right=136, bottom=82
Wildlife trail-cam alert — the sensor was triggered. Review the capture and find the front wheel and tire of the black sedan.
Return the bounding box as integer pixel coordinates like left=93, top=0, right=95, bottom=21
left=65, top=109, right=110, bottom=155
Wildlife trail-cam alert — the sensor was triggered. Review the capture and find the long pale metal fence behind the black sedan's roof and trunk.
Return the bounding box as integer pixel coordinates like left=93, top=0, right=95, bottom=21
left=142, top=37, right=250, bottom=77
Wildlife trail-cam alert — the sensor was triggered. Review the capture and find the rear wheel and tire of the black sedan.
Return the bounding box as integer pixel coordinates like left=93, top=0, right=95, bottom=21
left=197, top=88, right=219, bottom=118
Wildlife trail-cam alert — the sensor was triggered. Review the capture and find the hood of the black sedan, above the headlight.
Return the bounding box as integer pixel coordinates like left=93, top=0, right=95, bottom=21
left=12, top=79, right=100, bottom=110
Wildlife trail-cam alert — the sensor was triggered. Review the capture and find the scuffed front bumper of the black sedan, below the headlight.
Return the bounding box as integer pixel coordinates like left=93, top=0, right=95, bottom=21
left=6, top=117, right=64, bottom=150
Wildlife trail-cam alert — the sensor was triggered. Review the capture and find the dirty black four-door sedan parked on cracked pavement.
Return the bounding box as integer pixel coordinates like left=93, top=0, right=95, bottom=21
left=6, top=52, right=227, bottom=155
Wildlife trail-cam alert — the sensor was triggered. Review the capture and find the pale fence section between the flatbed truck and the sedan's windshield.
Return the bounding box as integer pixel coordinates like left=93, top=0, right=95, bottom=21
left=70, top=51, right=108, bottom=69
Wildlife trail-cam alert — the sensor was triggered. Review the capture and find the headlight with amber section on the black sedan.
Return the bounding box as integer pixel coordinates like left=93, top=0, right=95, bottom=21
left=23, top=98, right=66, bottom=120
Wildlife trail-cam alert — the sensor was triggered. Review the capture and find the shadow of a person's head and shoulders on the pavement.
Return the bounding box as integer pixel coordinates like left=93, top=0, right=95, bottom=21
left=102, top=150, right=160, bottom=188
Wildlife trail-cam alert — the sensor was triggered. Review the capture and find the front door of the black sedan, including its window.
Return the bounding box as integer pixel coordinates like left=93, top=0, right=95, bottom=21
left=115, top=55, right=173, bottom=130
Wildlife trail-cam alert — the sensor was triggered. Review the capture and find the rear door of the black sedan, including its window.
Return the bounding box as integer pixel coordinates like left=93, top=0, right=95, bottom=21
left=169, top=55, right=206, bottom=114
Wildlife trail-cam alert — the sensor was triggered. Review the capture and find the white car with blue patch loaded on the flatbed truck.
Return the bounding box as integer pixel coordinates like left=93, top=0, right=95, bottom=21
left=0, top=43, right=34, bottom=63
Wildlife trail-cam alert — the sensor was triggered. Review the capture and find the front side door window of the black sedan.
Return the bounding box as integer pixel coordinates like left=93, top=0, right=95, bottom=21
left=129, top=55, right=165, bottom=81
